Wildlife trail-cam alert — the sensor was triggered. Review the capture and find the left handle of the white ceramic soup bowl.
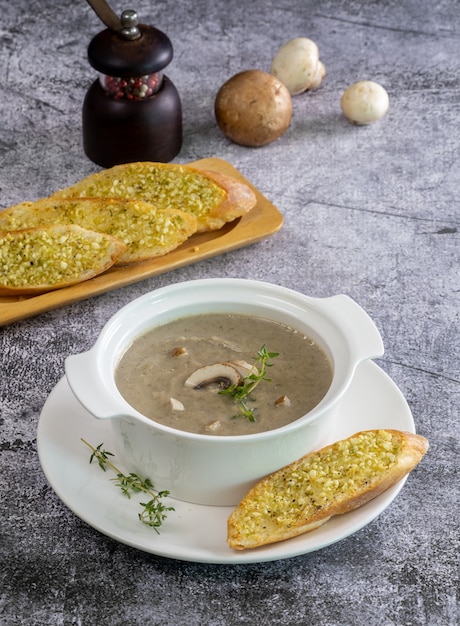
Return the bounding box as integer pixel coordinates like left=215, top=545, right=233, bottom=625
left=65, top=348, right=125, bottom=419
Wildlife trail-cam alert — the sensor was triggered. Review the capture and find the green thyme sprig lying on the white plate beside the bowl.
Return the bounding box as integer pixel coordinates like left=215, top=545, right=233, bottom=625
left=82, top=439, right=174, bottom=534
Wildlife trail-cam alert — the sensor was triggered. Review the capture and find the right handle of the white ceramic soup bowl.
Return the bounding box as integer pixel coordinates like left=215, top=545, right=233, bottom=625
left=317, top=294, right=384, bottom=363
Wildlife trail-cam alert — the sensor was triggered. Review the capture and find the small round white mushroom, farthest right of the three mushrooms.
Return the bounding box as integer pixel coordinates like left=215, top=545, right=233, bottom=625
left=340, top=80, right=390, bottom=125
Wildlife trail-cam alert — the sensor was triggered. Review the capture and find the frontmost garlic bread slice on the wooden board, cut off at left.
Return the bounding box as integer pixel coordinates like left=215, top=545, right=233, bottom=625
left=0, top=225, right=126, bottom=296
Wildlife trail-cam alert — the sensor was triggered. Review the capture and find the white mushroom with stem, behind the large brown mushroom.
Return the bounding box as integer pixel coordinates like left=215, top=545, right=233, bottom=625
left=270, top=37, right=326, bottom=96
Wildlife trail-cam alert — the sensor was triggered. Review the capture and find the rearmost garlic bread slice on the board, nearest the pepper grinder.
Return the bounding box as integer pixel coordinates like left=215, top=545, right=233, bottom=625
left=52, top=161, right=256, bottom=232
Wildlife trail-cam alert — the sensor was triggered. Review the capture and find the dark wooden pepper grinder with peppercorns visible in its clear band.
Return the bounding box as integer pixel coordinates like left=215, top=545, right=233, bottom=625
left=83, top=0, right=182, bottom=167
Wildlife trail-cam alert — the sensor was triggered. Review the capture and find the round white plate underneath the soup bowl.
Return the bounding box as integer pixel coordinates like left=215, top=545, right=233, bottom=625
left=37, top=361, right=415, bottom=564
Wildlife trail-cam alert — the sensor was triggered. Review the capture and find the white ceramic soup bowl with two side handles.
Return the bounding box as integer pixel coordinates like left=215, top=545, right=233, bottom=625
left=65, top=278, right=383, bottom=505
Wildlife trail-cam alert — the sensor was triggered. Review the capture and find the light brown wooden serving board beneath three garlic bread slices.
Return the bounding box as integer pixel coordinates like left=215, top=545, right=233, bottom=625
left=0, top=158, right=283, bottom=326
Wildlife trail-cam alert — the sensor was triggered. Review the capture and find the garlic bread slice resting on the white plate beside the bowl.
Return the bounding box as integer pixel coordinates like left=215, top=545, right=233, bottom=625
left=227, top=429, right=428, bottom=550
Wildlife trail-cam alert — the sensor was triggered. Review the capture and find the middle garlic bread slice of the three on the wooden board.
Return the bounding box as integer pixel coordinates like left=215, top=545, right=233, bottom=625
left=0, top=198, right=197, bottom=265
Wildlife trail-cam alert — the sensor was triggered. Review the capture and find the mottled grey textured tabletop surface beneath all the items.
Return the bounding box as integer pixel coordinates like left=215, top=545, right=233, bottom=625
left=0, top=0, right=460, bottom=626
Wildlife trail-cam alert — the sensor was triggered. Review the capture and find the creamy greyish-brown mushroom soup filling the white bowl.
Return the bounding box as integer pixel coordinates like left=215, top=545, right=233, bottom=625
left=115, top=313, right=332, bottom=436
